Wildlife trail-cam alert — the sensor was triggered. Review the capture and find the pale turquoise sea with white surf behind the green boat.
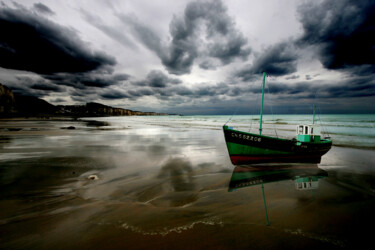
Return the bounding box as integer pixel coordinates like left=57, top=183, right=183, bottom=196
left=85, top=114, right=375, bottom=149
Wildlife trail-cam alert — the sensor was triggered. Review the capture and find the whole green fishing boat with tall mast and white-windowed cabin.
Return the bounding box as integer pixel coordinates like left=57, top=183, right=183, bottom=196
left=223, top=72, right=332, bottom=165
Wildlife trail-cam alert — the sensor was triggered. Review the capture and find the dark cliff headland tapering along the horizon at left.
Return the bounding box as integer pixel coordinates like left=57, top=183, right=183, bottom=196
left=0, top=84, right=168, bottom=117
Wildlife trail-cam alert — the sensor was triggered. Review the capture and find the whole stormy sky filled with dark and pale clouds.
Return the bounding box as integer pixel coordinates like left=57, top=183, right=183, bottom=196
left=0, top=0, right=375, bottom=115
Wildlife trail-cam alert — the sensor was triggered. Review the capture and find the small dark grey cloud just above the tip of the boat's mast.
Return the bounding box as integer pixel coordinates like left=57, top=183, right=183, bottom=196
left=235, top=42, right=298, bottom=81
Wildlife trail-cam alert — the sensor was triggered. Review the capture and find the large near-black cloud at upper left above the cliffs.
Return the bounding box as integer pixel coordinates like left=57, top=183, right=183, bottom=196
left=0, top=6, right=116, bottom=74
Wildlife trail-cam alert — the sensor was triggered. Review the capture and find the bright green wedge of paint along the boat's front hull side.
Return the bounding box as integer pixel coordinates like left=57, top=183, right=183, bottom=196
left=227, top=142, right=292, bottom=155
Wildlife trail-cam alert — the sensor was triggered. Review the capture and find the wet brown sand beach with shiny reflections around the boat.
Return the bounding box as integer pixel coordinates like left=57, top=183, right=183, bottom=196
left=0, top=118, right=375, bottom=249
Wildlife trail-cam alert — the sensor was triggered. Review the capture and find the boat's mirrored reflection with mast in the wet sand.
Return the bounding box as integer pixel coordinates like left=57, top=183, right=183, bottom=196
left=228, top=164, right=328, bottom=226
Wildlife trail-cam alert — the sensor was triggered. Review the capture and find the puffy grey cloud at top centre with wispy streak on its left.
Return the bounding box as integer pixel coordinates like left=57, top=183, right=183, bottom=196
left=119, top=1, right=250, bottom=75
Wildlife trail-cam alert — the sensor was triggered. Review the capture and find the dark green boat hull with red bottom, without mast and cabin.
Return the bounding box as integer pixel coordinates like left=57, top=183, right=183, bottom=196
left=223, top=126, right=332, bottom=165
